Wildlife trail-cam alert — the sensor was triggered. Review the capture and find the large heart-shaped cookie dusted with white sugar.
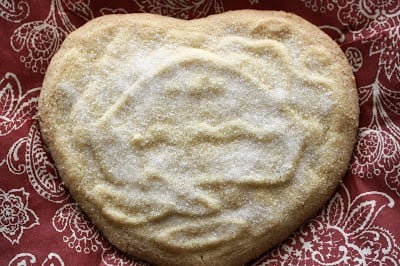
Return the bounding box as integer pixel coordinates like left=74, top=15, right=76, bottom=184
left=39, top=10, right=359, bottom=265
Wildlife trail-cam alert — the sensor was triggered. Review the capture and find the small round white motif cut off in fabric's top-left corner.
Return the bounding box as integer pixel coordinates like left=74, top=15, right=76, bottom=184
left=0, top=0, right=30, bottom=23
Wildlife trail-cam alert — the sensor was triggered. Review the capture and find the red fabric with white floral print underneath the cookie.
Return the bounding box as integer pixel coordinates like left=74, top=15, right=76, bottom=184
left=0, top=0, right=400, bottom=265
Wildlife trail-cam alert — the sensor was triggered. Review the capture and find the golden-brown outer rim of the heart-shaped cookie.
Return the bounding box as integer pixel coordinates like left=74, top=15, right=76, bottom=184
left=39, top=10, right=359, bottom=265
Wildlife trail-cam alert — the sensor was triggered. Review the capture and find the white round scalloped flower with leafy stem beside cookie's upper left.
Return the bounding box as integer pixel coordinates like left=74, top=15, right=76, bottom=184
left=11, top=0, right=93, bottom=74
